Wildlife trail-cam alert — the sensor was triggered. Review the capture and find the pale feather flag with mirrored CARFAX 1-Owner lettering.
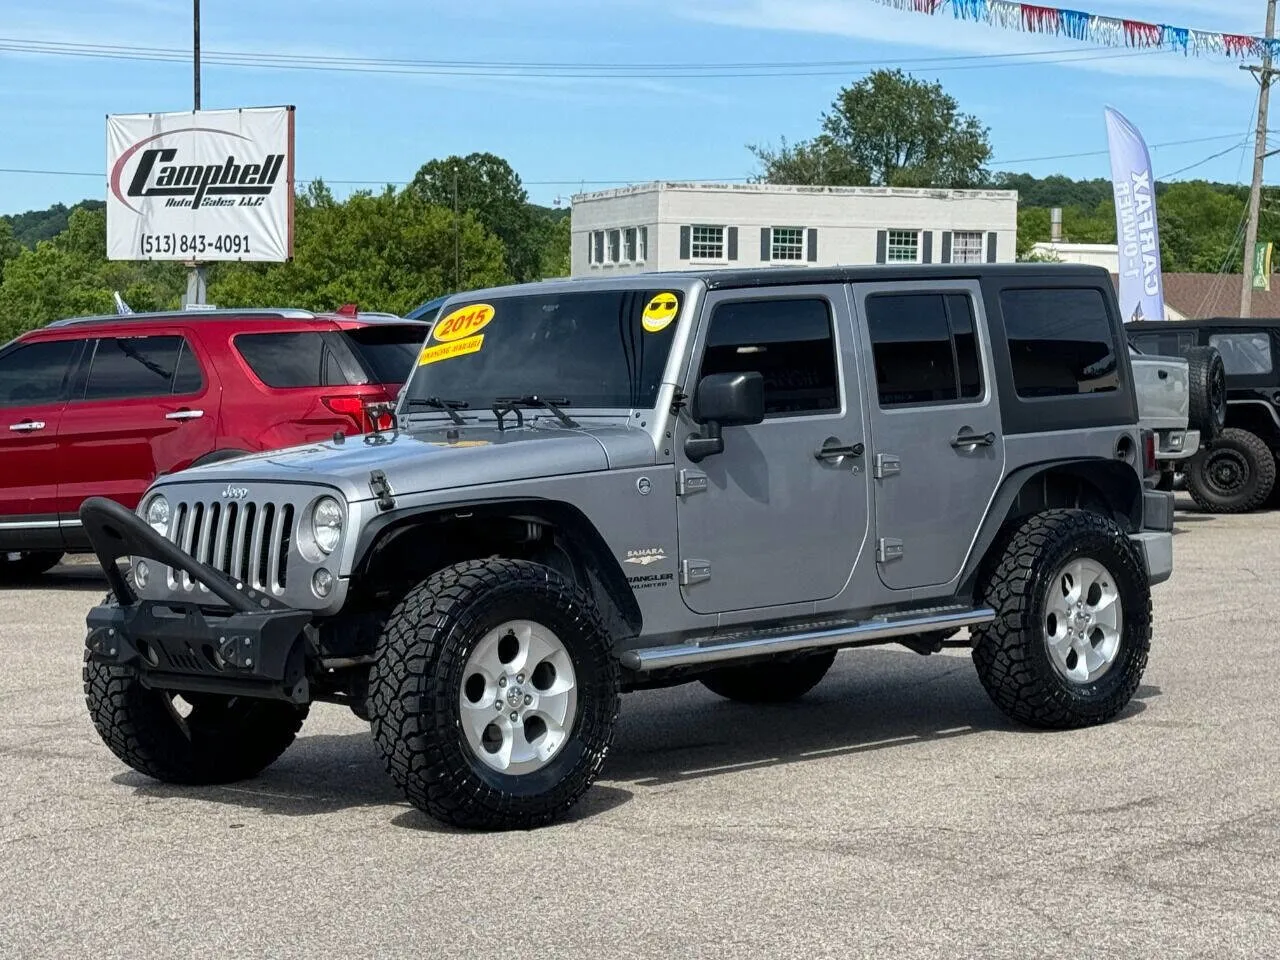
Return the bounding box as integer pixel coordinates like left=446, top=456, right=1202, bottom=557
left=1107, top=106, right=1165, bottom=323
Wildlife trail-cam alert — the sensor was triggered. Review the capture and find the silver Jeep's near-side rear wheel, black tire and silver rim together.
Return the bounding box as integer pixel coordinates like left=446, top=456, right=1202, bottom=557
left=973, top=509, right=1151, bottom=730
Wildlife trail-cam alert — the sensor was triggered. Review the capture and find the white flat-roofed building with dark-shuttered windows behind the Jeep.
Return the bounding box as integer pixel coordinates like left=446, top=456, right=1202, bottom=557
left=572, top=183, right=1018, bottom=276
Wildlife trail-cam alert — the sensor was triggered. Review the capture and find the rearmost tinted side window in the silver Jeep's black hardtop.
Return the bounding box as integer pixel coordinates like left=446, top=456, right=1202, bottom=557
left=1000, top=288, right=1120, bottom=398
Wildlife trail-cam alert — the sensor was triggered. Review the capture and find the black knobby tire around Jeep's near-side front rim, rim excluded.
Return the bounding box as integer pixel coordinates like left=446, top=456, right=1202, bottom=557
left=369, top=559, right=620, bottom=829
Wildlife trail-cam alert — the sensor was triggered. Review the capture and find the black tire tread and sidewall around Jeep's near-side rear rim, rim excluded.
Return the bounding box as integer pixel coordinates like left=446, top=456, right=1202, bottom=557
left=973, top=509, right=1151, bottom=730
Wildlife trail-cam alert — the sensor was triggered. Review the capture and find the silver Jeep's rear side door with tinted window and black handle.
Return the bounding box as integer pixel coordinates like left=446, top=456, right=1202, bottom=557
left=854, top=282, right=1005, bottom=590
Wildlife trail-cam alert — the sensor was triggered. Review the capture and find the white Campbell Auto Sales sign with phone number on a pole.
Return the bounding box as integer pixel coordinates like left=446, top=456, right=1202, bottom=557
left=106, top=106, right=293, bottom=262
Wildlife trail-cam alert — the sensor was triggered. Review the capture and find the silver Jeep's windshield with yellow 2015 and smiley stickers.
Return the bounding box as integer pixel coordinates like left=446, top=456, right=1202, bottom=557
left=404, top=291, right=684, bottom=410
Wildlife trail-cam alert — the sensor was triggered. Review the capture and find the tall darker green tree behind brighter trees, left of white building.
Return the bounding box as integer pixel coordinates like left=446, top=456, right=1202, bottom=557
left=408, top=154, right=543, bottom=282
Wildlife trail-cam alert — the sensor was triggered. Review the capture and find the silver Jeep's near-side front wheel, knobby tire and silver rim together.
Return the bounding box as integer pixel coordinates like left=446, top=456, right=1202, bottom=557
left=369, top=559, right=618, bottom=829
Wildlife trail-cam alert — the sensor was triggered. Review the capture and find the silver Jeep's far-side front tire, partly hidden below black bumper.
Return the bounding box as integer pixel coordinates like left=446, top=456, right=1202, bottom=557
left=83, top=594, right=307, bottom=786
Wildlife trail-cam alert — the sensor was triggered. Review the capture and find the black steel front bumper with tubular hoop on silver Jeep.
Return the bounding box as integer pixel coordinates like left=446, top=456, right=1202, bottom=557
left=79, top=497, right=314, bottom=703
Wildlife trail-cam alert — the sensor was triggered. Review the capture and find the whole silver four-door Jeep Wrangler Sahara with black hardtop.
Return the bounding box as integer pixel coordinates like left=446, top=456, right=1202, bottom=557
left=81, top=265, right=1174, bottom=828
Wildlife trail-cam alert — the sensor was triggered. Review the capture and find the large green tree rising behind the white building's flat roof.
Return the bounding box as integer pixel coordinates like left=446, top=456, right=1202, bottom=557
left=750, top=70, right=991, bottom=187
